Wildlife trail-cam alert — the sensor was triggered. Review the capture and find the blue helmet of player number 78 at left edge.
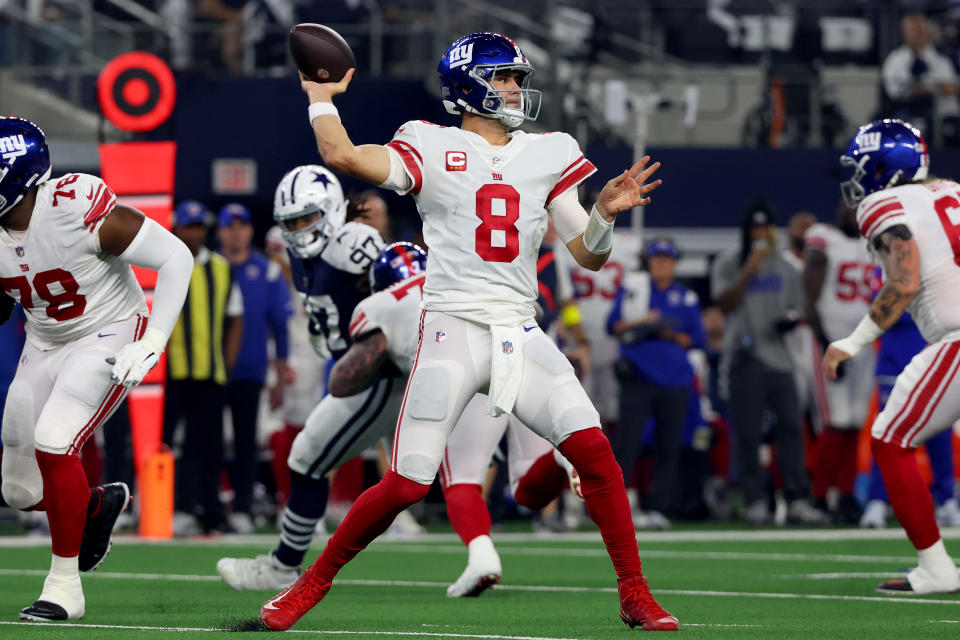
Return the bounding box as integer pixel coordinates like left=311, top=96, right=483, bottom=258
left=0, top=116, right=52, bottom=216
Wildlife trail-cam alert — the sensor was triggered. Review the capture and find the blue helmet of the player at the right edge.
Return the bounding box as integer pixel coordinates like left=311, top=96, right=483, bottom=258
left=840, top=119, right=930, bottom=208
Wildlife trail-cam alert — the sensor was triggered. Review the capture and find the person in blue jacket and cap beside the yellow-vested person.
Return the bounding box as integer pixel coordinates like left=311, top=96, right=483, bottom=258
left=217, top=202, right=293, bottom=533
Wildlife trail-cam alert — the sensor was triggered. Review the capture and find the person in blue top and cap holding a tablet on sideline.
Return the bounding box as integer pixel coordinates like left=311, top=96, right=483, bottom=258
left=607, top=238, right=706, bottom=529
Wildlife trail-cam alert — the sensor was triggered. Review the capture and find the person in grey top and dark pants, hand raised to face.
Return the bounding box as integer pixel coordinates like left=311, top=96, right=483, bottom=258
left=710, top=199, right=826, bottom=524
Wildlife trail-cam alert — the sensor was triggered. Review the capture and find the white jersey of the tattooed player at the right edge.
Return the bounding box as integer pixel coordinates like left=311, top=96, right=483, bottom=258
left=857, top=180, right=960, bottom=343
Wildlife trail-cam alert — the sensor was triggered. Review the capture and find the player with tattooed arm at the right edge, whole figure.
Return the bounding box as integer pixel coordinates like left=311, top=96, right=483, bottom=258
left=823, top=120, right=960, bottom=593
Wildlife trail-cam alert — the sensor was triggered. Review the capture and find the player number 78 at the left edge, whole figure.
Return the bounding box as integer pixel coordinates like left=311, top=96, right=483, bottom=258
left=0, top=117, right=193, bottom=621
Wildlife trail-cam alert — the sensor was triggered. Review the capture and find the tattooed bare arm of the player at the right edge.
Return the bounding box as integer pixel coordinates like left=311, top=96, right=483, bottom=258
left=823, top=224, right=920, bottom=380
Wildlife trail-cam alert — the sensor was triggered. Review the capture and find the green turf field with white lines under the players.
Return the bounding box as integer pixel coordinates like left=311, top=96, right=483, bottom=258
left=0, top=530, right=960, bottom=640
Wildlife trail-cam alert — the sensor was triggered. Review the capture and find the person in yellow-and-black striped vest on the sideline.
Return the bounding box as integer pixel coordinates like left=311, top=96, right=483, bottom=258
left=163, top=200, right=243, bottom=535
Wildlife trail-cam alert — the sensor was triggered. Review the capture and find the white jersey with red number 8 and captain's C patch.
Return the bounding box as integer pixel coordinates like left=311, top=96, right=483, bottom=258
left=388, top=121, right=596, bottom=326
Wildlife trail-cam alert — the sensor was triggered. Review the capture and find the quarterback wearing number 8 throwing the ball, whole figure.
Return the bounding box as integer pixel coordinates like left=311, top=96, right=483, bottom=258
left=260, top=33, right=679, bottom=630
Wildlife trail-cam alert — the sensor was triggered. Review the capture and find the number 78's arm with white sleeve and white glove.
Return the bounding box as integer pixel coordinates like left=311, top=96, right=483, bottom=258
left=98, top=205, right=193, bottom=387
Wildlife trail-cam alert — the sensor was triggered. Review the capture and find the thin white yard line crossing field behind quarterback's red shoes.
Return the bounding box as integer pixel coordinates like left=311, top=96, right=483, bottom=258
left=0, top=569, right=960, bottom=606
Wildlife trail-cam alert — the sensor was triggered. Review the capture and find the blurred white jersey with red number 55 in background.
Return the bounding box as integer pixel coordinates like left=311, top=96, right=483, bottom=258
left=803, top=223, right=877, bottom=341
